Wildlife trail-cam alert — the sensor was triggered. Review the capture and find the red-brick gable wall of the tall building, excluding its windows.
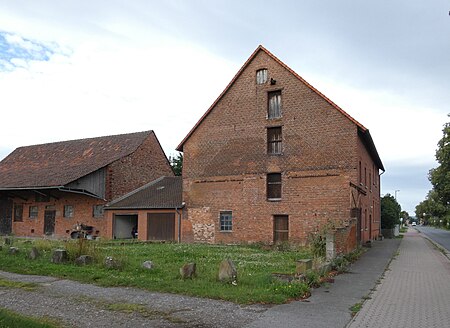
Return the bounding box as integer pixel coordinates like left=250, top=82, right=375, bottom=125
left=183, top=52, right=370, bottom=243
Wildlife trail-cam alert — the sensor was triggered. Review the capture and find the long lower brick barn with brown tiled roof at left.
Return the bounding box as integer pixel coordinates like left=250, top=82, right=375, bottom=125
left=0, top=131, right=173, bottom=237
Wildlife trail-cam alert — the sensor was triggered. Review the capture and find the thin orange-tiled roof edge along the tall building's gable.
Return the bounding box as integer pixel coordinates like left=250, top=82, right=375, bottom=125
left=177, top=45, right=384, bottom=170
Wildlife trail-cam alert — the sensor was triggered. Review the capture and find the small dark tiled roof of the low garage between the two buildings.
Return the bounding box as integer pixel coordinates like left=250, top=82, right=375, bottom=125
left=105, top=177, right=183, bottom=210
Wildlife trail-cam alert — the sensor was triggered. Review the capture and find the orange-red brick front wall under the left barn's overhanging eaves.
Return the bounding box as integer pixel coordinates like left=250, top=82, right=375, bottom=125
left=12, top=191, right=106, bottom=238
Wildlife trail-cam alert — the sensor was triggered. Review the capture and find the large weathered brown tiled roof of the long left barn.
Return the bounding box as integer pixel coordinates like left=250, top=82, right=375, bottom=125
left=0, top=131, right=153, bottom=189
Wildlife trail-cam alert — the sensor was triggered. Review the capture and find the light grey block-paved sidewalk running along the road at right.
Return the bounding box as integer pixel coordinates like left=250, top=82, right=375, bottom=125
left=348, top=229, right=450, bottom=328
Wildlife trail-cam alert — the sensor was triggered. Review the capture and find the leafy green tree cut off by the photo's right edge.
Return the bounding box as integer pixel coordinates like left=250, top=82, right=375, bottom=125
left=428, top=115, right=450, bottom=206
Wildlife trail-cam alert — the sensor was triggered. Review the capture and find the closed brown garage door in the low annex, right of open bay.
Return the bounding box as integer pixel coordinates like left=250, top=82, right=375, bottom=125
left=147, top=213, right=175, bottom=240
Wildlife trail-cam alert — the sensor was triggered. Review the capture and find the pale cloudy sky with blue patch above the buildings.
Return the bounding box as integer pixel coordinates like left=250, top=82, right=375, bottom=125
left=0, top=0, right=450, bottom=215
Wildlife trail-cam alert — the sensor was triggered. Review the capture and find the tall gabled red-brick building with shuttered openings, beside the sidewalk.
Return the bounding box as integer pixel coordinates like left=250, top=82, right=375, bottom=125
left=177, top=46, right=384, bottom=252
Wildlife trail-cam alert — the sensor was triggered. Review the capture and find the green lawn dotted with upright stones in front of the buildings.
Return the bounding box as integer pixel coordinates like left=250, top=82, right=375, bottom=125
left=0, top=239, right=317, bottom=304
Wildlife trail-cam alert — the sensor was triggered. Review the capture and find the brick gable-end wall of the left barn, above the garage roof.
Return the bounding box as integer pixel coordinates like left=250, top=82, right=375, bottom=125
left=106, top=133, right=174, bottom=200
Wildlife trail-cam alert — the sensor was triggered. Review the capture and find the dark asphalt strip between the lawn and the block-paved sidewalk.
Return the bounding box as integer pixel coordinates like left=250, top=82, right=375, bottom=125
left=245, top=239, right=401, bottom=328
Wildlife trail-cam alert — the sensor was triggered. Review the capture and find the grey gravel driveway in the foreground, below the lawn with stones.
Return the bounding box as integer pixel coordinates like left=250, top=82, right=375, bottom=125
left=0, top=271, right=268, bottom=328
